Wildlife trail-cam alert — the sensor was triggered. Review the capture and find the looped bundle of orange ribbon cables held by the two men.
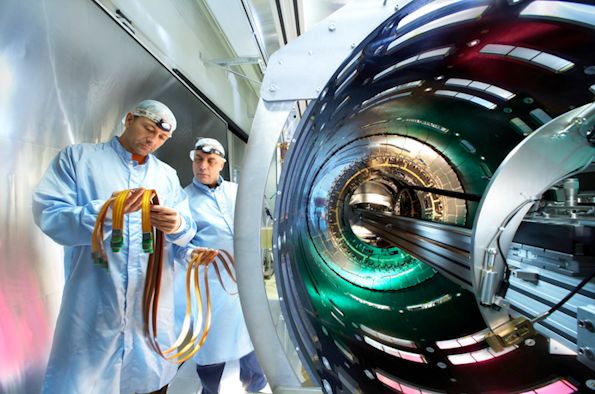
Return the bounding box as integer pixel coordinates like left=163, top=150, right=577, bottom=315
left=91, top=190, right=237, bottom=363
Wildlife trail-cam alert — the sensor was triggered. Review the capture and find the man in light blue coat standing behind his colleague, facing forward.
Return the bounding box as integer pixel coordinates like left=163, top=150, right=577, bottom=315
left=177, top=138, right=270, bottom=394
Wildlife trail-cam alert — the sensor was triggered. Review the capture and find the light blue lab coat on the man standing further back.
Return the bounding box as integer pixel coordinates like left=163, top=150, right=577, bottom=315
left=176, top=177, right=254, bottom=365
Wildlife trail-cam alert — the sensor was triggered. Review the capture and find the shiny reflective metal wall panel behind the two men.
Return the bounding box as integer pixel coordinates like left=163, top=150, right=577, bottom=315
left=0, top=0, right=227, bottom=393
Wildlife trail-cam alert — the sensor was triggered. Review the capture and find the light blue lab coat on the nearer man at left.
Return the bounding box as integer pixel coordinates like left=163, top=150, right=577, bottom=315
left=33, top=137, right=196, bottom=394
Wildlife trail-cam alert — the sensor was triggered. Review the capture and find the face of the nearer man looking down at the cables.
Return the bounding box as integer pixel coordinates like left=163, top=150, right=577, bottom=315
left=120, top=113, right=171, bottom=156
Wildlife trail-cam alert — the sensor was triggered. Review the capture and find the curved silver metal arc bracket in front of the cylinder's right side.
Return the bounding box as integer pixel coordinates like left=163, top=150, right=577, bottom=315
left=471, top=103, right=595, bottom=328
